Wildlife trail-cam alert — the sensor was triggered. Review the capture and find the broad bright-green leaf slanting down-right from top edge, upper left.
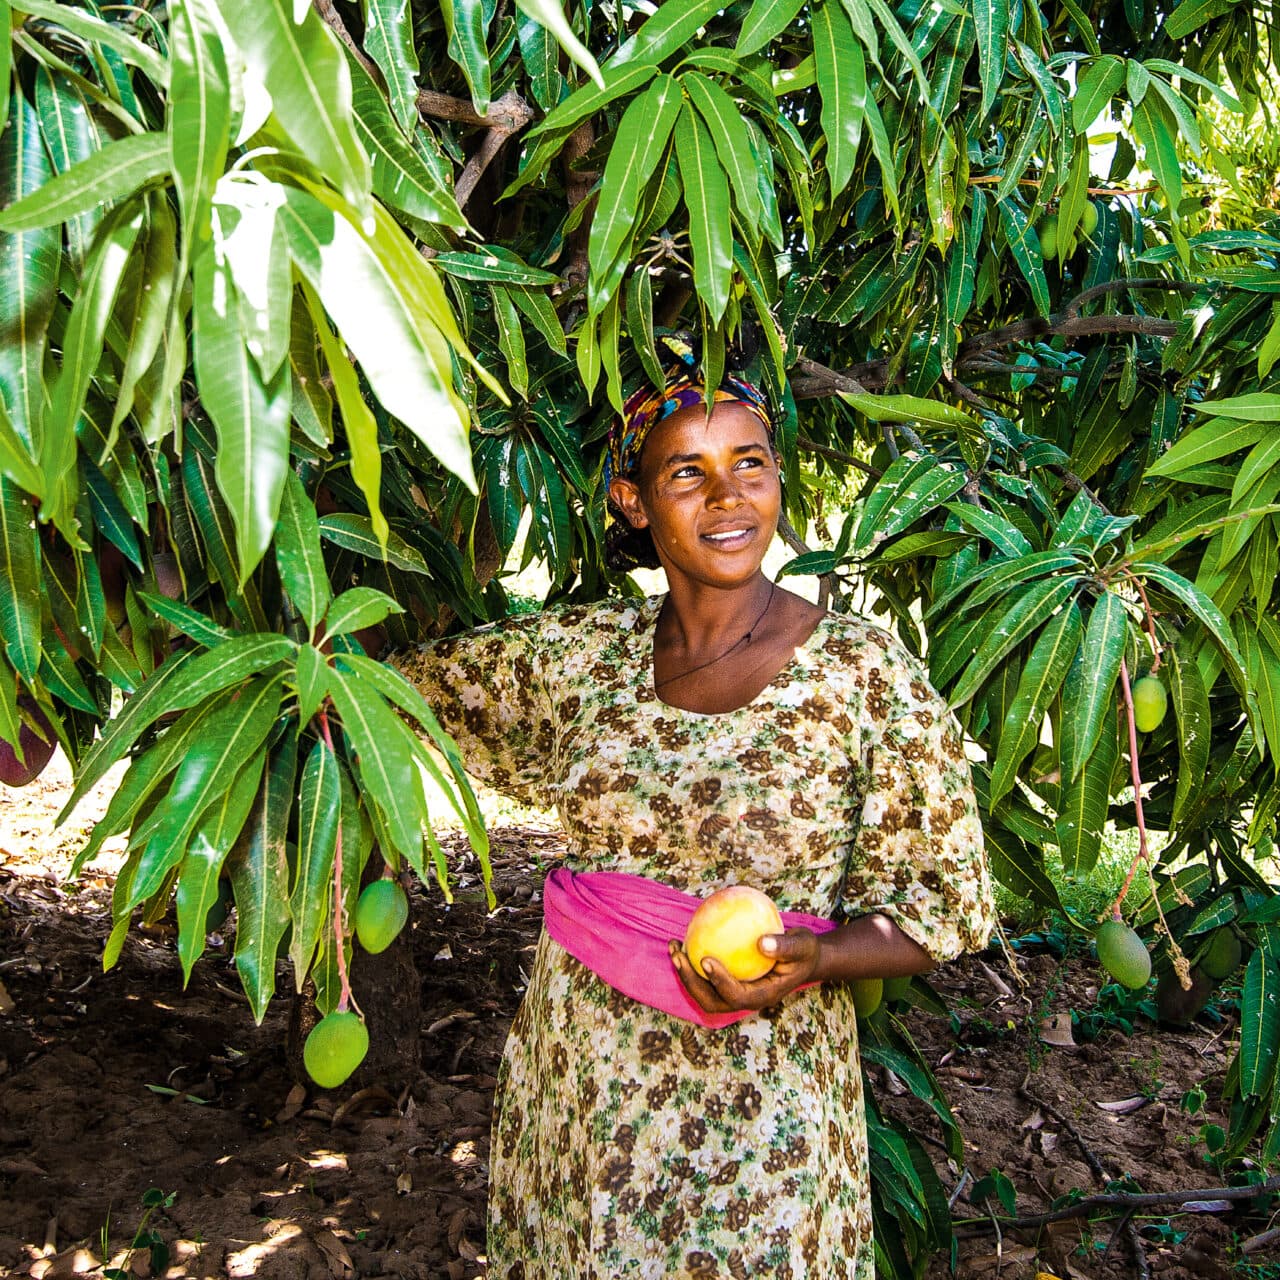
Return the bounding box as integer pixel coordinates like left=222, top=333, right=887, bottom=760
left=219, top=0, right=370, bottom=216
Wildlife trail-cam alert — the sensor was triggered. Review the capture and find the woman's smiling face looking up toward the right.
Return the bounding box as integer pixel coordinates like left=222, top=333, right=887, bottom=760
left=611, top=401, right=782, bottom=588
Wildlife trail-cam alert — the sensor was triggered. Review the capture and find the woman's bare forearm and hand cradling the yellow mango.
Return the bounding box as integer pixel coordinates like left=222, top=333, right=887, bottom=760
left=671, top=915, right=933, bottom=1014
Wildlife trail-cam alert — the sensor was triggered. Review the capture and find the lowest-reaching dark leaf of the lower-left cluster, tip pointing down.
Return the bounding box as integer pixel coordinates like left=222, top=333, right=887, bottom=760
left=230, top=733, right=298, bottom=1025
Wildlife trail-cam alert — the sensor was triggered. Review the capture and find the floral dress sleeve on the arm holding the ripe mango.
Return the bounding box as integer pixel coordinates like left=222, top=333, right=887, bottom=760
left=844, top=664, right=995, bottom=961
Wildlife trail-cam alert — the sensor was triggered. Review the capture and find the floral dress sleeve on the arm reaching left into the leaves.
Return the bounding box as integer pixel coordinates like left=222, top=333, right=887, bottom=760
left=389, top=614, right=554, bottom=808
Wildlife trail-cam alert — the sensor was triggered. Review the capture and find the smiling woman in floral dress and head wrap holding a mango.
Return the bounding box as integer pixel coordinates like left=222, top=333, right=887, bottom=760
left=399, top=355, right=991, bottom=1280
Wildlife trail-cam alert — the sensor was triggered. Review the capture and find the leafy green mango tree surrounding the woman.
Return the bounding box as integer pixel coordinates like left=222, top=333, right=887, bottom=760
left=0, top=0, right=1280, bottom=1274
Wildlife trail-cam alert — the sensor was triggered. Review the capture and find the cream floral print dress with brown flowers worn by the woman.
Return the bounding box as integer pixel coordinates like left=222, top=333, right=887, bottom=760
left=396, top=599, right=992, bottom=1280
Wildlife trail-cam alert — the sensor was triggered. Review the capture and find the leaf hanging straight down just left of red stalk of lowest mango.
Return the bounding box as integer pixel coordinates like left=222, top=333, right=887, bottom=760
left=289, top=742, right=342, bottom=991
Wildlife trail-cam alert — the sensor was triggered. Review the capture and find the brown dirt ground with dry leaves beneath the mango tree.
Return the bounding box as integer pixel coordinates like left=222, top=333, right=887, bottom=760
left=0, top=752, right=1280, bottom=1280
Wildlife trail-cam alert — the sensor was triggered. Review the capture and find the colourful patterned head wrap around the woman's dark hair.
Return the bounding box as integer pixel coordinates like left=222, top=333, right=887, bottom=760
left=604, top=334, right=773, bottom=568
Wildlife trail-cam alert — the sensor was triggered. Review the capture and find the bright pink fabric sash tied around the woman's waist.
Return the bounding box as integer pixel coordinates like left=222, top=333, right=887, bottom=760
left=543, top=867, right=836, bottom=1027
